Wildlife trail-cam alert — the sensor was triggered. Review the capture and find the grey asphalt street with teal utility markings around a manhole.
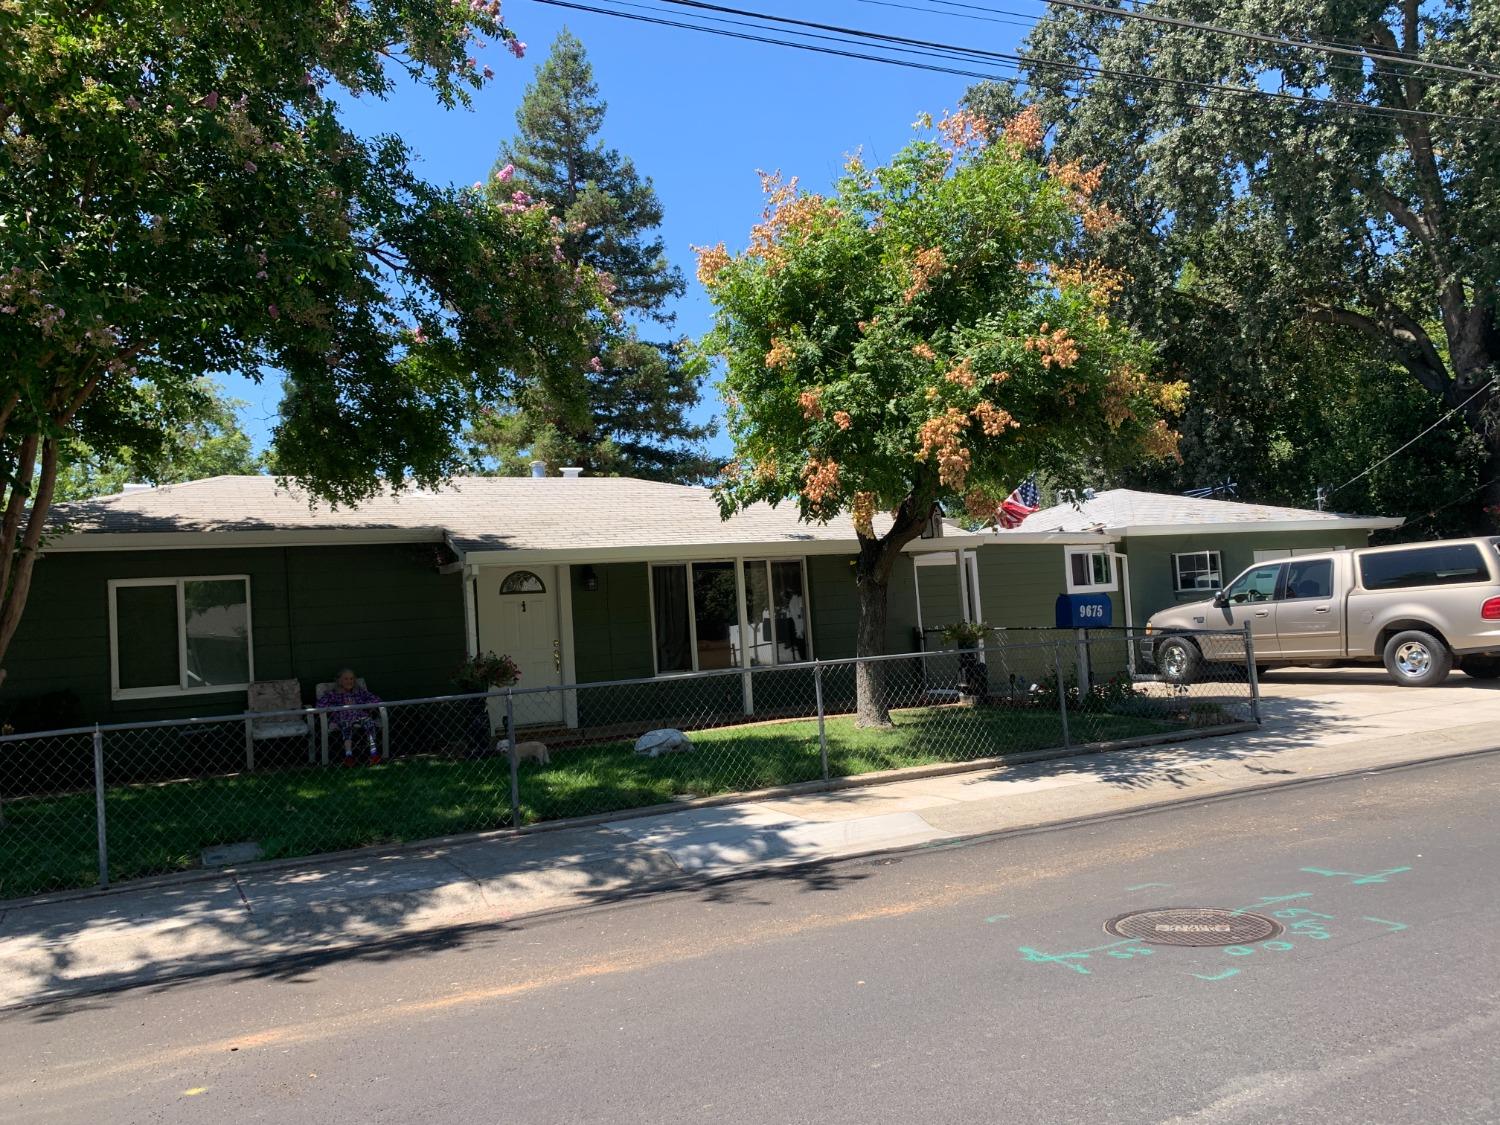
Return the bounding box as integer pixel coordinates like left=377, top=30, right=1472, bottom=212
left=0, top=755, right=1500, bottom=1125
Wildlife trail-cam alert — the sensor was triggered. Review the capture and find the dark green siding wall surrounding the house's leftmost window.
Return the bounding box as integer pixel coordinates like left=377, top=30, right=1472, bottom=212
left=0, top=545, right=464, bottom=723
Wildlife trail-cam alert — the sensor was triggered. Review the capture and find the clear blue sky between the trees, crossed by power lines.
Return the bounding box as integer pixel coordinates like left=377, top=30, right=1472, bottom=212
left=227, top=0, right=1043, bottom=452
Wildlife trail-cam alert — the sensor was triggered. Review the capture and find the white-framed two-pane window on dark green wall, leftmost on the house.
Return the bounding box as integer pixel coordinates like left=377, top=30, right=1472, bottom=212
left=110, top=575, right=255, bottom=699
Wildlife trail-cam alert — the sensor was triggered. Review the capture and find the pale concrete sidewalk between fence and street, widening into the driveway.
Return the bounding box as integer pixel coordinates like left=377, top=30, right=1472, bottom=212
left=0, top=672, right=1500, bottom=1007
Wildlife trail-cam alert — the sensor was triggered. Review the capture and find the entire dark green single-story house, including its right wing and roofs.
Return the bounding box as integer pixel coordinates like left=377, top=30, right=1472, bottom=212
left=0, top=470, right=1398, bottom=729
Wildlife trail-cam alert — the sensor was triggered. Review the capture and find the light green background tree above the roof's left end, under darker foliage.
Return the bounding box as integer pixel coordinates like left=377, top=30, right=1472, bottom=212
left=53, top=378, right=264, bottom=503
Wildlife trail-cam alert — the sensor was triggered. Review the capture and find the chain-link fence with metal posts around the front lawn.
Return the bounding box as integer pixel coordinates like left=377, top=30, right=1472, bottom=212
left=0, top=630, right=1259, bottom=899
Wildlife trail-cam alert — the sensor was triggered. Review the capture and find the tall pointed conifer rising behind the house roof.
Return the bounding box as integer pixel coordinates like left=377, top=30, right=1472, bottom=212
left=470, top=30, right=714, bottom=482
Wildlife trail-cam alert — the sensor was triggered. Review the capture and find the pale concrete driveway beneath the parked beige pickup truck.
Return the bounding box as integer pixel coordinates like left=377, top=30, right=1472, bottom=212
left=1260, top=668, right=1500, bottom=746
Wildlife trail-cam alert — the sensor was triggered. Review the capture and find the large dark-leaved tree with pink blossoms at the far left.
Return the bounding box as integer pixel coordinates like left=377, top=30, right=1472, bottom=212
left=0, top=0, right=600, bottom=693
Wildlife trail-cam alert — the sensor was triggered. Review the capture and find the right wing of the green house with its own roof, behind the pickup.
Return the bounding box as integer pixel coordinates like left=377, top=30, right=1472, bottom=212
left=995, top=489, right=1404, bottom=627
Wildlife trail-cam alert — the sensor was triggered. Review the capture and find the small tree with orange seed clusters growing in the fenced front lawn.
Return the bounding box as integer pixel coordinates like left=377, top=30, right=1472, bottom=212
left=699, top=113, right=1184, bottom=723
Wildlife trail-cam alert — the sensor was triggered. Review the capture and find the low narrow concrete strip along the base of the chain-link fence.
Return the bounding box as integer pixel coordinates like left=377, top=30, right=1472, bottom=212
left=0, top=722, right=1260, bottom=914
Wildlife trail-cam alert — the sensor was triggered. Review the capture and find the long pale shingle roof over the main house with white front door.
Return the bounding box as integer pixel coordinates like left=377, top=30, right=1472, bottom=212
left=51, top=477, right=930, bottom=552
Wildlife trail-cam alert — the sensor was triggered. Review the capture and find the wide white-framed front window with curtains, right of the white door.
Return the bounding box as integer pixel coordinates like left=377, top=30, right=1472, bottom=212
left=651, top=558, right=812, bottom=675
